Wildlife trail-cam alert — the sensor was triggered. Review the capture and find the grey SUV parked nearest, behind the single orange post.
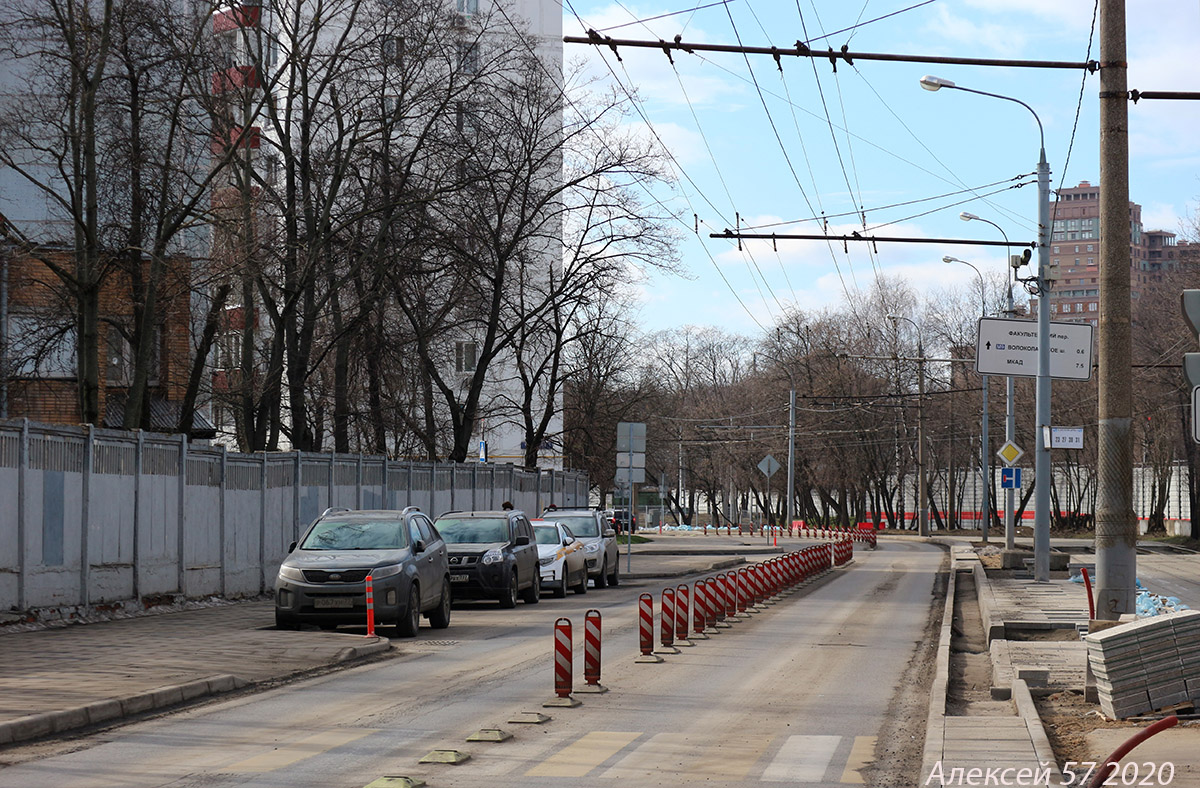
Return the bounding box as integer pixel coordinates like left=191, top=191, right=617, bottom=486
left=275, top=506, right=450, bottom=637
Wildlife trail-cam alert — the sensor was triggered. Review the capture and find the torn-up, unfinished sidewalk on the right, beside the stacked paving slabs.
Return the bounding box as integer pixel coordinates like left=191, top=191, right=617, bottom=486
left=922, top=537, right=1200, bottom=788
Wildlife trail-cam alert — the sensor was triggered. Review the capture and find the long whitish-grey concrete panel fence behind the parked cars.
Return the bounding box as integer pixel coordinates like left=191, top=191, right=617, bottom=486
left=0, top=420, right=588, bottom=610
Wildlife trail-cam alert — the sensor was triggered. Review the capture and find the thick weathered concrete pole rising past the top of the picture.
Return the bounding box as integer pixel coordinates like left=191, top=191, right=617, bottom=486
left=1096, top=0, right=1138, bottom=620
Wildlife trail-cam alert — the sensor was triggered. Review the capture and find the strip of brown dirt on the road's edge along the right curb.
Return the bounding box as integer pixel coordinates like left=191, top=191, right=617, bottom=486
left=862, top=555, right=949, bottom=788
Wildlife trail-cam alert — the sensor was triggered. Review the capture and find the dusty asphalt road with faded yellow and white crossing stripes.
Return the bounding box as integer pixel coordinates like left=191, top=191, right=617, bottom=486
left=0, top=542, right=942, bottom=788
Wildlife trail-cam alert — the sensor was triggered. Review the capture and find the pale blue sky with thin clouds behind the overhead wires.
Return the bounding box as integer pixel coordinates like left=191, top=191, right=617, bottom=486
left=563, top=0, right=1200, bottom=335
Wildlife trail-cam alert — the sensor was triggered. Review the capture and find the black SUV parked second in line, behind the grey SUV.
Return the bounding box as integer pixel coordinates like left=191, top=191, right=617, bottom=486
left=434, top=510, right=541, bottom=607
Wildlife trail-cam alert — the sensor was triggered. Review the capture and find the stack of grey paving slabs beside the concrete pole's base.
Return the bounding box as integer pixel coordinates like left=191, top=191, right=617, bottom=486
left=1085, top=610, right=1200, bottom=720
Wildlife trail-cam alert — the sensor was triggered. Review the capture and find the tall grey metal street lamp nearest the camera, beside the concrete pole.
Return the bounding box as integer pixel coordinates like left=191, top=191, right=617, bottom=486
left=920, top=76, right=1051, bottom=583
